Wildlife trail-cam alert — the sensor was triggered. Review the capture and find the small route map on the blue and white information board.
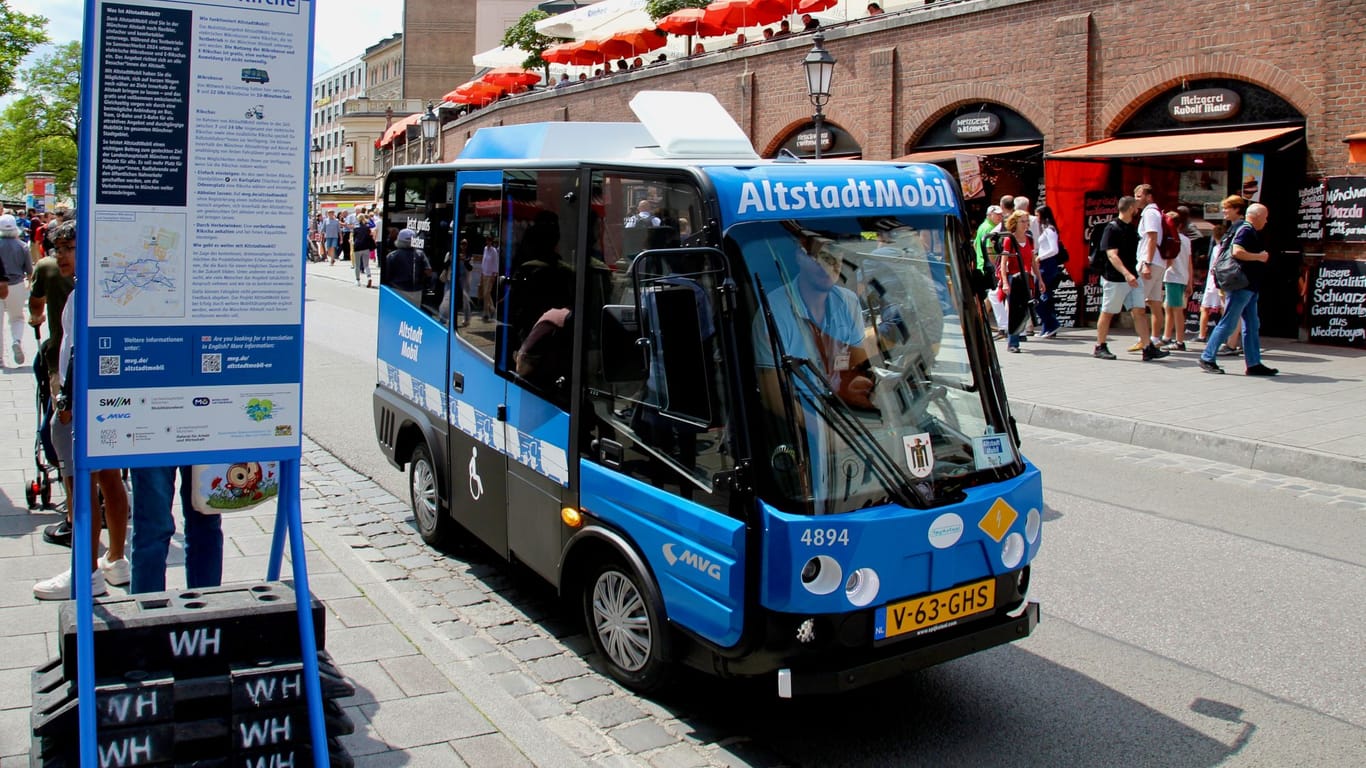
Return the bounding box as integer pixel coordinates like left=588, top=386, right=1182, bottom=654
left=94, top=213, right=186, bottom=317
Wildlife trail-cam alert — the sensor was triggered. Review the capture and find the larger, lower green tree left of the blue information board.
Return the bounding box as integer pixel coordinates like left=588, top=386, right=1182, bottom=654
left=0, top=42, right=81, bottom=190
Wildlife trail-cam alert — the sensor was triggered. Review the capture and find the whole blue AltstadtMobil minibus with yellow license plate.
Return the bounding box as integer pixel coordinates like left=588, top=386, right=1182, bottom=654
left=374, top=92, right=1044, bottom=697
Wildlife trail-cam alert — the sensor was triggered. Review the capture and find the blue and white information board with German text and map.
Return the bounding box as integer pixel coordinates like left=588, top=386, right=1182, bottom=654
left=74, top=0, right=313, bottom=470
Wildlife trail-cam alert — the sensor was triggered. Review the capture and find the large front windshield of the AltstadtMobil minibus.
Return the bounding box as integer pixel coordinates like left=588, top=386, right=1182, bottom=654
left=727, top=217, right=1014, bottom=514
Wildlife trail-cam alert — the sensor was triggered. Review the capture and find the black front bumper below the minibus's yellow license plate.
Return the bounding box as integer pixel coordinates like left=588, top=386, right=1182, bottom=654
left=775, top=603, right=1038, bottom=696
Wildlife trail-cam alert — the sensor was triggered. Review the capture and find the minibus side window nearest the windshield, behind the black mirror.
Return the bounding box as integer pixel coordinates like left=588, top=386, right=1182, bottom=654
left=579, top=172, right=734, bottom=512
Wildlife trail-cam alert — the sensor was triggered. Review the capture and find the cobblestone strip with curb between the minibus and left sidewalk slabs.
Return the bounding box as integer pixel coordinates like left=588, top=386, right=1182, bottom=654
left=302, top=440, right=783, bottom=768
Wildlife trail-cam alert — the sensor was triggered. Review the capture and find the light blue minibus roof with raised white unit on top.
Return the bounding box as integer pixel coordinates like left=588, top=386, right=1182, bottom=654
left=460, top=90, right=759, bottom=161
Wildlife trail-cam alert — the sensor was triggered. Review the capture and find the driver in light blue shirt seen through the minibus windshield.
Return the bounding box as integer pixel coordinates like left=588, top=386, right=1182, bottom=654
left=754, top=236, right=874, bottom=409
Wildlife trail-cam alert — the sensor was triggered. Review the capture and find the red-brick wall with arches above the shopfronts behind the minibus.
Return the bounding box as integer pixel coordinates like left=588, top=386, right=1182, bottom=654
left=385, top=0, right=1366, bottom=334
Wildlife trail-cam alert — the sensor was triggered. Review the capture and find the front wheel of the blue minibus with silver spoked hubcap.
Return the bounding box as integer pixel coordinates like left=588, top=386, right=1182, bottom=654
left=582, top=559, right=675, bottom=693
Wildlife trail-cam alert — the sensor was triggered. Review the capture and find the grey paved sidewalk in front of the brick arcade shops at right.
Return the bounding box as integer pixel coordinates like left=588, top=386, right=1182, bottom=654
left=997, top=328, right=1366, bottom=488
